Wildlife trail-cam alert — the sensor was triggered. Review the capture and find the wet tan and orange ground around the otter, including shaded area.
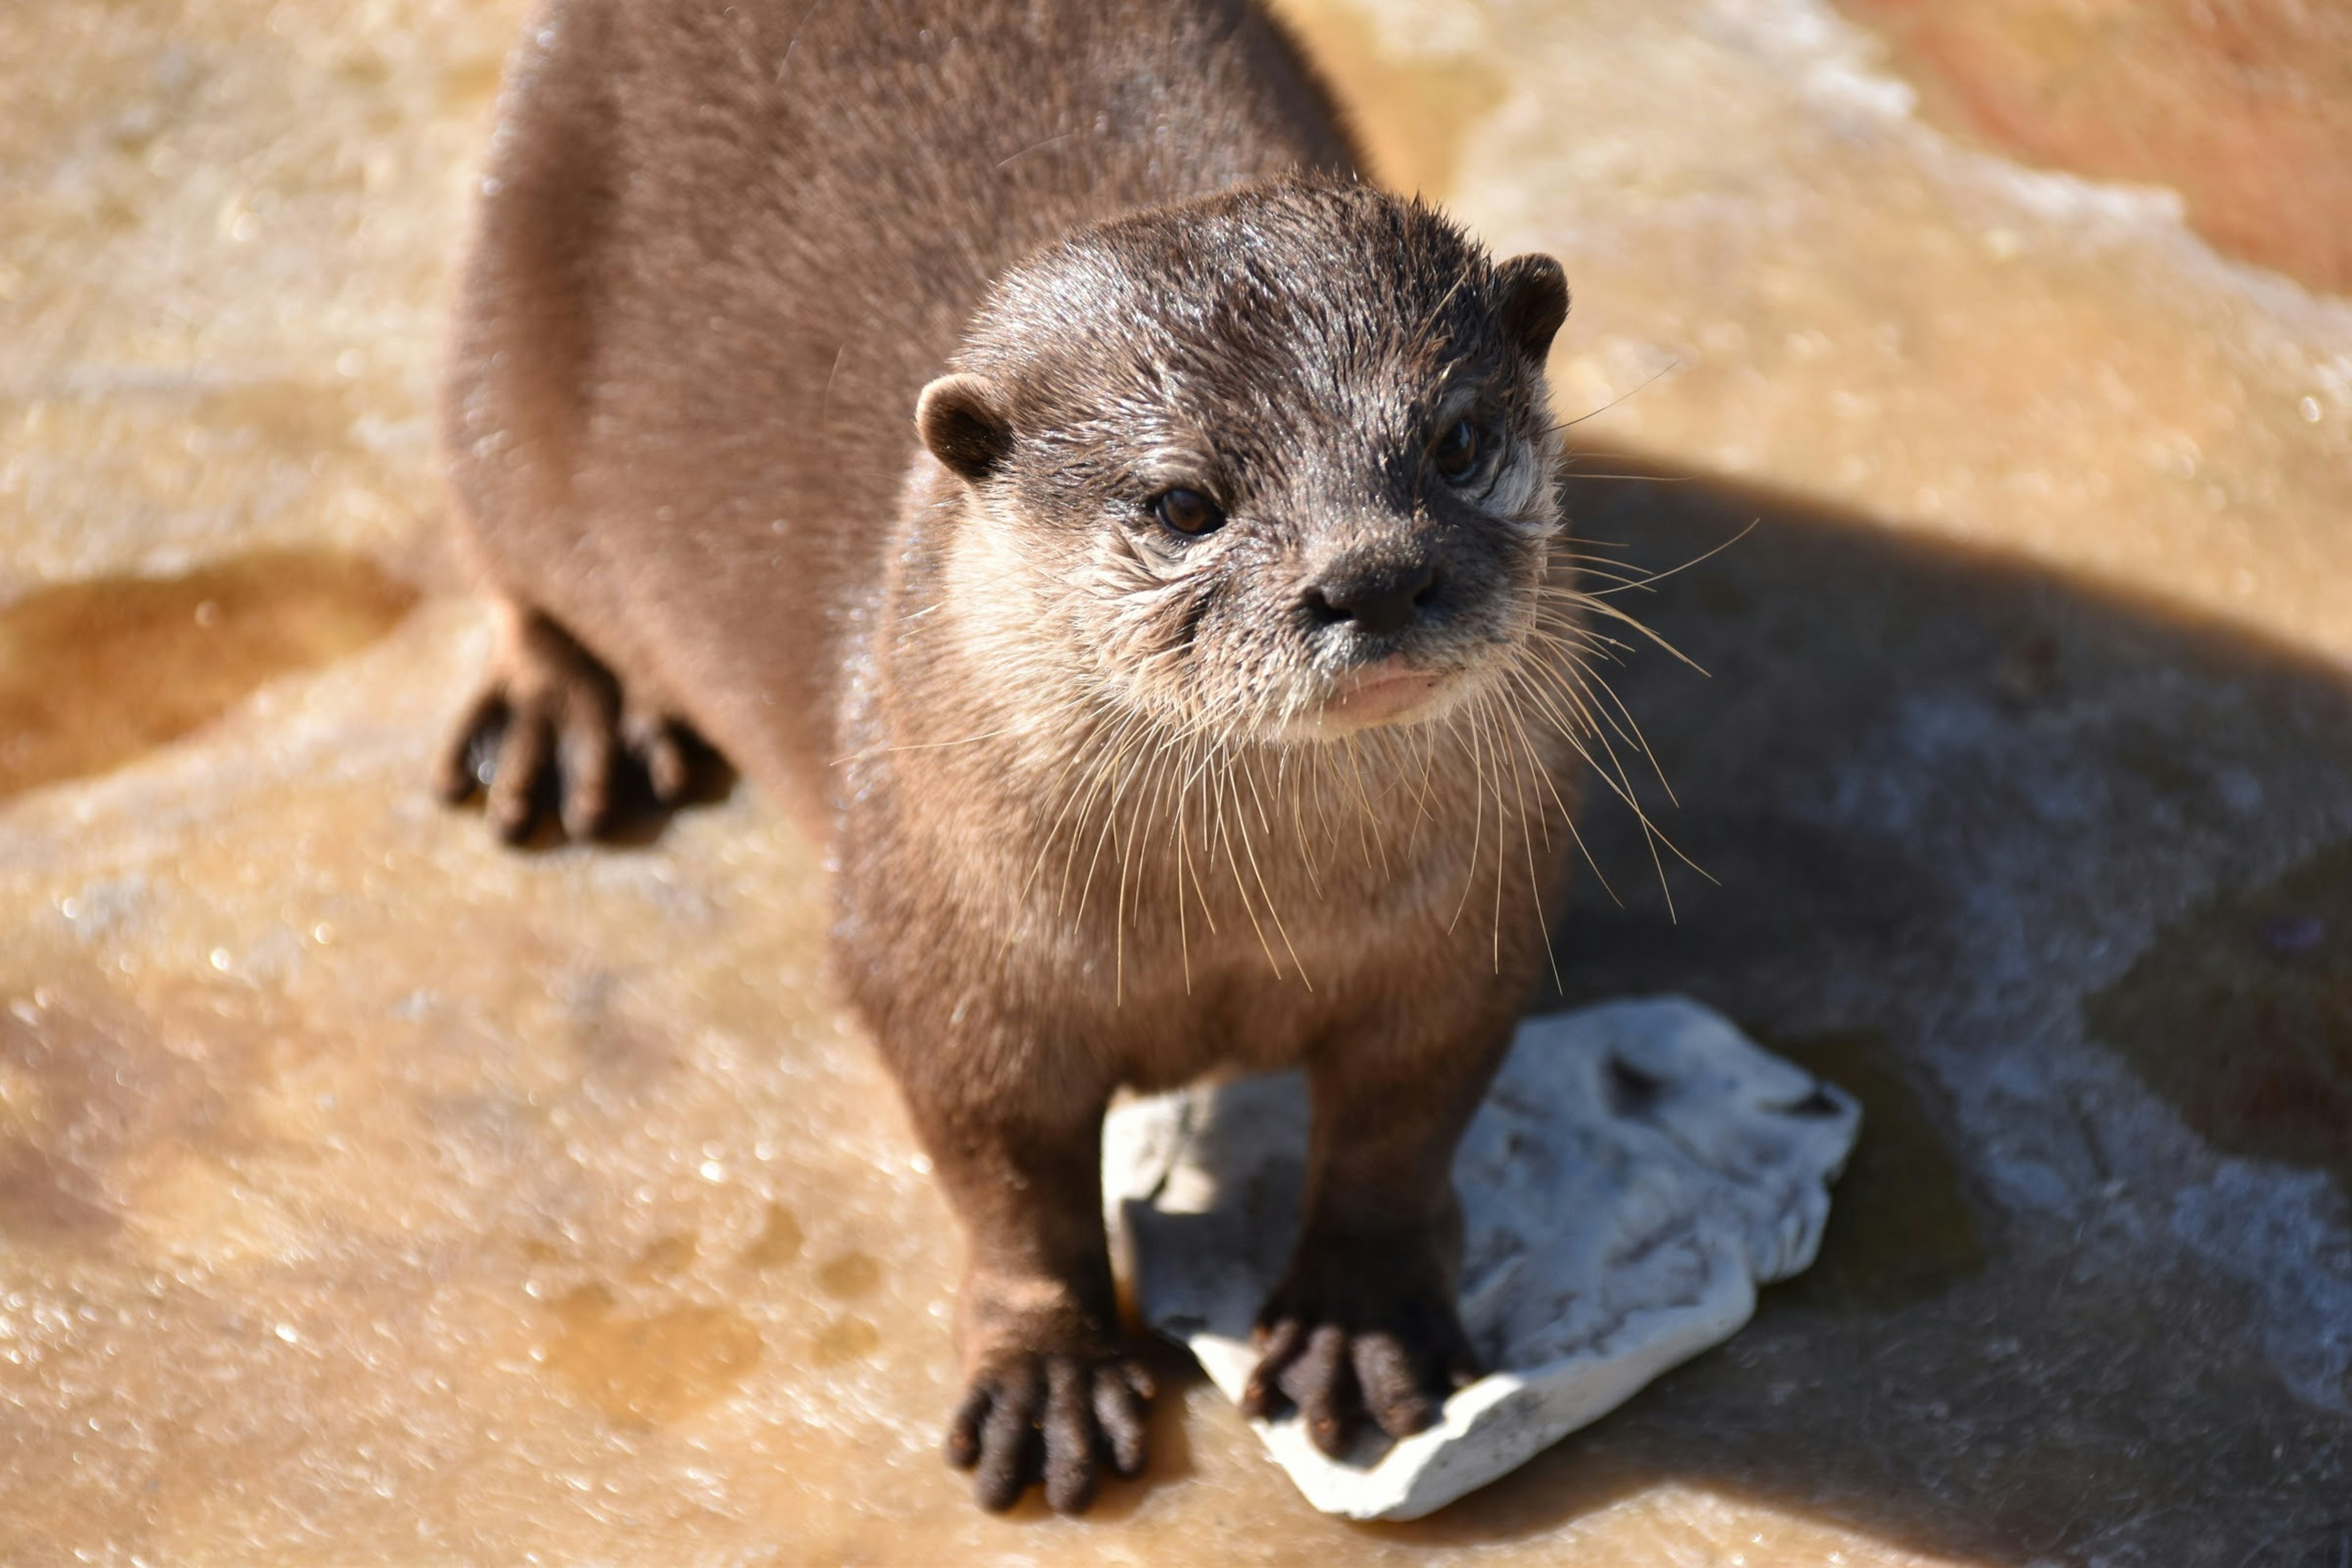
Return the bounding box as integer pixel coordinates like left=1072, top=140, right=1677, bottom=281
left=0, top=0, right=2352, bottom=1568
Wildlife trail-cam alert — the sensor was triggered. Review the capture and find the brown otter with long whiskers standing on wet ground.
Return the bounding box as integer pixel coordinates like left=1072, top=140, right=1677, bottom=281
left=442, top=0, right=1597, bottom=1512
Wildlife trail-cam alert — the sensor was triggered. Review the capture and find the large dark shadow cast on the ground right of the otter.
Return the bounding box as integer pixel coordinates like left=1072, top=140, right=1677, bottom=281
left=1385, top=456, right=2352, bottom=1568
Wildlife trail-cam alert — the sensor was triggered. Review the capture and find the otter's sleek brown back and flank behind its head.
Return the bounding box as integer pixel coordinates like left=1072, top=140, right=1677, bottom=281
left=449, top=0, right=1350, bottom=809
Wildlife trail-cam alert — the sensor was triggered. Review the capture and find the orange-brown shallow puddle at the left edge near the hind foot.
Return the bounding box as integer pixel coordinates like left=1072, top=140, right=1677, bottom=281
left=0, top=550, right=417, bottom=797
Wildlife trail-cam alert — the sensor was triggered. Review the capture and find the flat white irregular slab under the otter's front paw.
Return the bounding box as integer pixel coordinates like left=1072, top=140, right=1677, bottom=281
left=1103, top=997, right=1860, bottom=1518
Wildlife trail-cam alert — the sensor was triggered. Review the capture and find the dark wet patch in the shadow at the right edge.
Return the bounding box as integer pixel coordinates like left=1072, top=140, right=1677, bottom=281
left=2084, top=839, right=2352, bottom=1192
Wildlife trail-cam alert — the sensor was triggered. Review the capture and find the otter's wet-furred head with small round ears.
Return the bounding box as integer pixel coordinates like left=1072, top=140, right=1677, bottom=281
left=918, top=181, right=1569, bottom=741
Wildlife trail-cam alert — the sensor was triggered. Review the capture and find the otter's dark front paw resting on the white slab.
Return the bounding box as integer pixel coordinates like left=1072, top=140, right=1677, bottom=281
left=1242, top=1257, right=1477, bottom=1460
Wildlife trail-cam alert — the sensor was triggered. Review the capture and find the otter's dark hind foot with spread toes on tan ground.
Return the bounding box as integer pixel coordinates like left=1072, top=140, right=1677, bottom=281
left=435, top=609, right=701, bottom=844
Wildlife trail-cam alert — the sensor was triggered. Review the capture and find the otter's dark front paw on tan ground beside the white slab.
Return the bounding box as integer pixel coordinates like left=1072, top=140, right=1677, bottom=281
left=948, top=1352, right=1153, bottom=1514
